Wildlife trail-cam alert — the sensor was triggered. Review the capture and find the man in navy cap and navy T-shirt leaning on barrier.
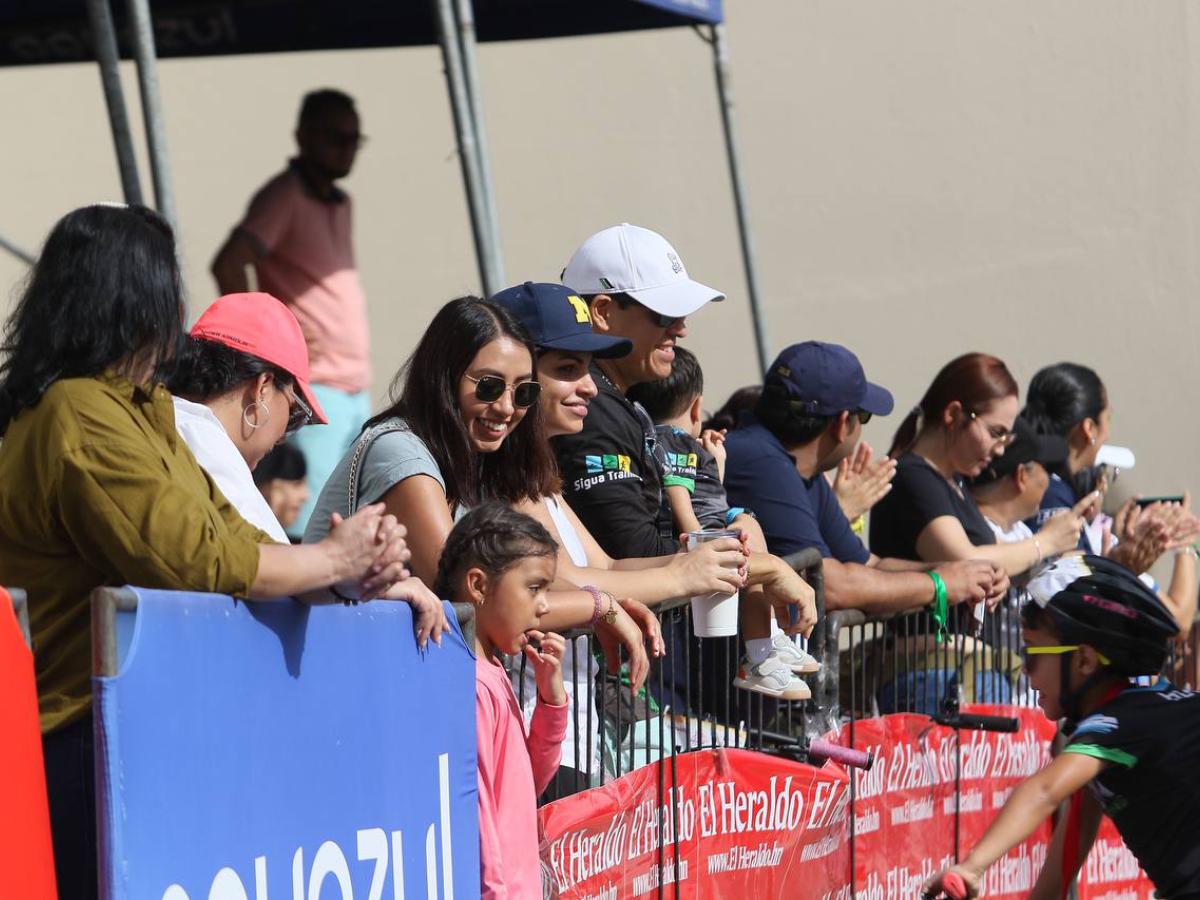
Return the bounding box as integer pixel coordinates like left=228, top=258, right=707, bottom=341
left=725, top=341, right=997, bottom=612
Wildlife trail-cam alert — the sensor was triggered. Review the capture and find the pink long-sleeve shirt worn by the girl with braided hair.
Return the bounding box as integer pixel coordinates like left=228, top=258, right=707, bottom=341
left=475, top=658, right=568, bottom=900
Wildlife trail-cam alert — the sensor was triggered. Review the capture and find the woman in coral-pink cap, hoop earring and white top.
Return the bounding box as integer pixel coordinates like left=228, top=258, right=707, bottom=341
left=167, top=293, right=326, bottom=544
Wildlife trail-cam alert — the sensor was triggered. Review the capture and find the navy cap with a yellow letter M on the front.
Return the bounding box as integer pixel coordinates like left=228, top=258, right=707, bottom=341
left=492, top=281, right=634, bottom=359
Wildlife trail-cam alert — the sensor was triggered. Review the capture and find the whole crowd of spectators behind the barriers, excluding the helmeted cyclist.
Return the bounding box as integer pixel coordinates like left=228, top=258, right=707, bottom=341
left=0, top=96, right=1200, bottom=896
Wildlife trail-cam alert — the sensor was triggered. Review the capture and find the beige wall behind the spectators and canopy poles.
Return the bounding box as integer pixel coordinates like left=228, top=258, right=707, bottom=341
left=0, top=0, right=1200, bottom=508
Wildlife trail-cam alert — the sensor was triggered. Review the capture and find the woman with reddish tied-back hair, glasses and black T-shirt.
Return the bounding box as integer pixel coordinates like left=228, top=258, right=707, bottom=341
left=871, top=353, right=1084, bottom=578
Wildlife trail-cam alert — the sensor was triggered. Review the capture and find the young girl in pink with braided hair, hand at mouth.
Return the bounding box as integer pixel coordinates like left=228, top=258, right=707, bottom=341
left=437, top=502, right=568, bottom=900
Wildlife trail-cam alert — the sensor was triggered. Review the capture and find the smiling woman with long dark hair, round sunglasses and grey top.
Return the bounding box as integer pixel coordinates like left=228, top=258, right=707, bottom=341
left=305, top=296, right=653, bottom=686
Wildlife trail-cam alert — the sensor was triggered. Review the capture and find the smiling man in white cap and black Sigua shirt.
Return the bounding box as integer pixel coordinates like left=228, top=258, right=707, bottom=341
left=553, top=224, right=725, bottom=559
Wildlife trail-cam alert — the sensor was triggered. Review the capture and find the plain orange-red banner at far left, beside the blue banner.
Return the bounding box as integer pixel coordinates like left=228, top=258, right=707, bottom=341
left=0, top=588, right=55, bottom=900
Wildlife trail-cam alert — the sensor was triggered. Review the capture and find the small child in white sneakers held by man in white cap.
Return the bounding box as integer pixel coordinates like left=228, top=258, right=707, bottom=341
left=629, top=346, right=821, bottom=700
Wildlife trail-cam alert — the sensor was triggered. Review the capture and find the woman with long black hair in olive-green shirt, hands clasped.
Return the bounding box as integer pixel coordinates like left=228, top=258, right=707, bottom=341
left=0, top=204, right=404, bottom=898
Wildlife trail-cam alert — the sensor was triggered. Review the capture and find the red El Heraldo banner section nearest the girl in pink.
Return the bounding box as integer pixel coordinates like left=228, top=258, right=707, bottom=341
left=540, top=750, right=850, bottom=900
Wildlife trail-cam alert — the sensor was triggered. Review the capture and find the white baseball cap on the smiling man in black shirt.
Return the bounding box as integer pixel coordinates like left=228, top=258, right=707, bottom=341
left=563, top=222, right=725, bottom=317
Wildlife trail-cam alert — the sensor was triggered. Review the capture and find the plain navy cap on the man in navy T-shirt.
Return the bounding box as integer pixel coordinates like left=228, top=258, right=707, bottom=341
left=763, top=341, right=895, bottom=416
